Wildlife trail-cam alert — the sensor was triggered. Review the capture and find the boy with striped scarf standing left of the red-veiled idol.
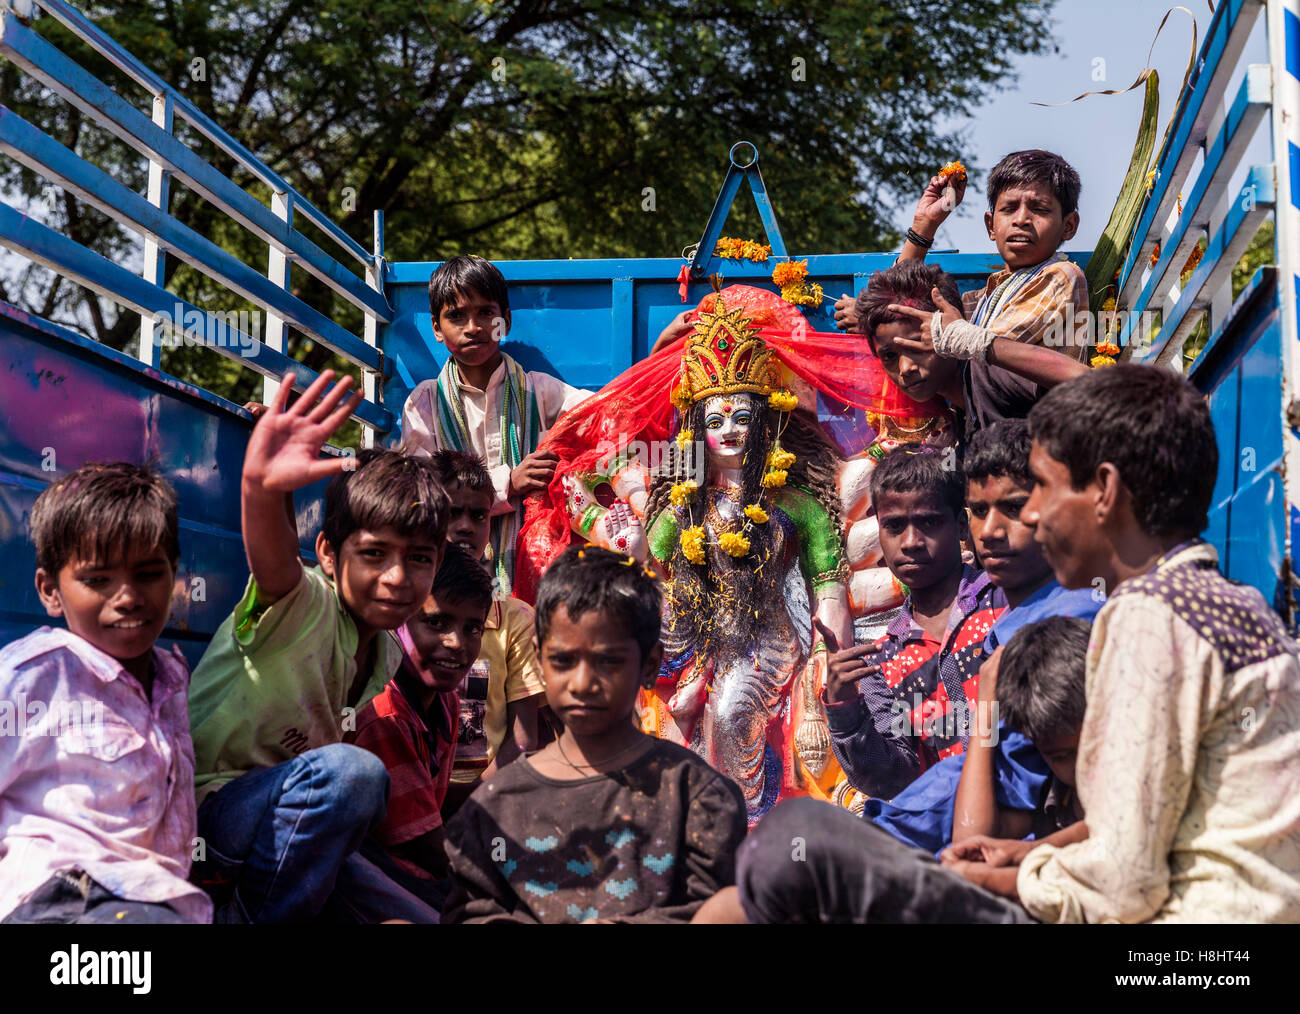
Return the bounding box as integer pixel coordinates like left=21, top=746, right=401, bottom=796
left=400, top=254, right=590, bottom=598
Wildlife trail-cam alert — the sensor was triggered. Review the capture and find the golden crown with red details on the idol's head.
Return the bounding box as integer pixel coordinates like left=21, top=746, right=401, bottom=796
left=673, top=295, right=776, bottom=406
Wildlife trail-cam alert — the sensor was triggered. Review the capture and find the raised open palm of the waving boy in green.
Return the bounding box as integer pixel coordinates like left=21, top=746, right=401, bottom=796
left=243, top=369, right=361, bottom=493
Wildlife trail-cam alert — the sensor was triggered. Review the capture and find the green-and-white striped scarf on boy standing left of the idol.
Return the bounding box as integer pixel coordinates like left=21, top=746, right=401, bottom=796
left=434, top=352, right=542, bottom=598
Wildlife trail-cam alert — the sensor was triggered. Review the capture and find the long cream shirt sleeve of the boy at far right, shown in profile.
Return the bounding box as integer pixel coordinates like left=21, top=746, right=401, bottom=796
left=1018, top=594, right=1201, bottom=923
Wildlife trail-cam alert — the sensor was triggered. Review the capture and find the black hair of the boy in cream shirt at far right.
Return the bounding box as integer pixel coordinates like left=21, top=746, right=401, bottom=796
left=1030, top=363, right=1218, bottom=538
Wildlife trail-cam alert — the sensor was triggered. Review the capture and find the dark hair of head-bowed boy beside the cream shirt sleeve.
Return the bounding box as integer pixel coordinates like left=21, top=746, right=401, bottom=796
left=997, top=616, right=1092, bottom=742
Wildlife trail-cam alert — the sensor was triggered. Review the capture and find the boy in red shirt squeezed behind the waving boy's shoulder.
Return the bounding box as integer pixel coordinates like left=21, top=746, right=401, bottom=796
left=346, top=542, right=493, bottom=907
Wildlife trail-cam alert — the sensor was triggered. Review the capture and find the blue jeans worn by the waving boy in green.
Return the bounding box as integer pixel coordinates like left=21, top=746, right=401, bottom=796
left=196, top=744, right=438, bottom=923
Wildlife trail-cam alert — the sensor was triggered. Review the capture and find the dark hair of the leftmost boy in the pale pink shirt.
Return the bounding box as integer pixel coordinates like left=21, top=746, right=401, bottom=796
left=29, top=462, right=181, bottom=577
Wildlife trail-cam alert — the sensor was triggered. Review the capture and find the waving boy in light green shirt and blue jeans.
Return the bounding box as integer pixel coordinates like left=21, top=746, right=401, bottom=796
left=190, top=371, right=447, bottom=923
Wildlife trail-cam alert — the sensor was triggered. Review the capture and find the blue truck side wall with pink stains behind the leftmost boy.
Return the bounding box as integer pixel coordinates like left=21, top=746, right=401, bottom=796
left=0, top=313, right=335, bottom=664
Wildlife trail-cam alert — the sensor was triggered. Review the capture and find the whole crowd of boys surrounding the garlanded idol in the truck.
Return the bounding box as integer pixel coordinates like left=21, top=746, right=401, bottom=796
left=0, top=151, right=1300, bottom=923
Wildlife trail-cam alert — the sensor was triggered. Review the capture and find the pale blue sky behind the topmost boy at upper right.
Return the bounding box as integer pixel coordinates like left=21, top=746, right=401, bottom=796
left=925, top=0, right=1271, bottom=252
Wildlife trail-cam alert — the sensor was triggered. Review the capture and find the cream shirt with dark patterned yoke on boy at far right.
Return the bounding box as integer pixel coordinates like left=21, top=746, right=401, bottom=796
left=1017, top=540, right=1300, bottom=923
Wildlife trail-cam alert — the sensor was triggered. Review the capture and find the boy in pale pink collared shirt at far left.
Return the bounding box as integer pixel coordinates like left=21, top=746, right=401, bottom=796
left=0, top=463, right=212, bottom=923
